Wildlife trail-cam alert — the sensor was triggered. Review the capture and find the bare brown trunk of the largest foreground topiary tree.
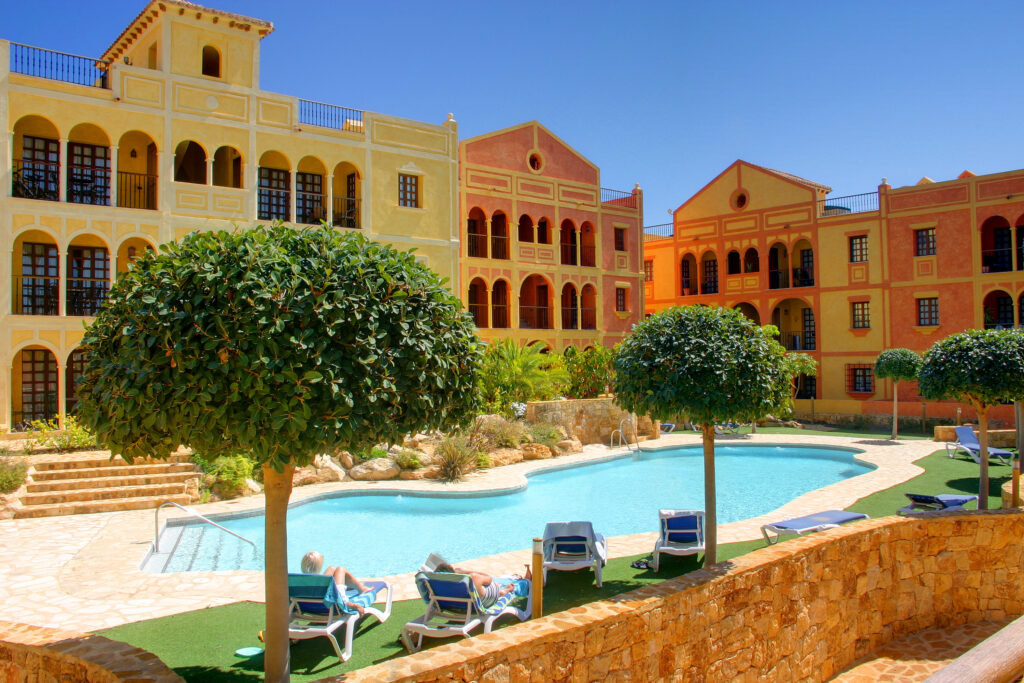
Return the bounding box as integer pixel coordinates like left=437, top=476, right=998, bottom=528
left=263, top=465, right=295, bottom=683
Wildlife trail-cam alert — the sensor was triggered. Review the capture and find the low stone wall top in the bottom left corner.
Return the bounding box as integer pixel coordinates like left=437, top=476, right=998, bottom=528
left=0, top=622, right=183, bottom=683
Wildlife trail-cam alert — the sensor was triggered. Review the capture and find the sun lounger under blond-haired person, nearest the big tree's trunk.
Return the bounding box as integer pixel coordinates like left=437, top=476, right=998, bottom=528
left=288, top=573, right=391, bottom=661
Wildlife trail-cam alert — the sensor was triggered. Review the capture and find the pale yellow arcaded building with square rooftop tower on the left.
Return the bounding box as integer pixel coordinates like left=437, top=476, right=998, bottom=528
left=0, top=0, right=460, bottom=431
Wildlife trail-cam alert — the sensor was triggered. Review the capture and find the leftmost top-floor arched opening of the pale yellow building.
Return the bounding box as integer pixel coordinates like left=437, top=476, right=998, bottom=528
left=10, top=116, right=60, bottom=202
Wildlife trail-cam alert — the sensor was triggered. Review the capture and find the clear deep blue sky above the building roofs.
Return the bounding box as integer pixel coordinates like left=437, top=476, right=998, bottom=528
left=0, top=0, right=1024, bottom=225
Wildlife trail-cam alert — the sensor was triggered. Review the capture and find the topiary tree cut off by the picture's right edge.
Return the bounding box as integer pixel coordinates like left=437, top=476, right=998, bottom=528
left=918, top=330, right=1024, bottom=510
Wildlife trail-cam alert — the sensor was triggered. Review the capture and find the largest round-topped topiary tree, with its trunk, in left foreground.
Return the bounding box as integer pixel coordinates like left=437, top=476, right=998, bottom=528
left=79, top=224, right=479, bottom=681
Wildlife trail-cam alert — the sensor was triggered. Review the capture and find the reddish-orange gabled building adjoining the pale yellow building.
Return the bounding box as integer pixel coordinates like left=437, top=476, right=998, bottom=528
left=459, top=121, right=643, bottom=350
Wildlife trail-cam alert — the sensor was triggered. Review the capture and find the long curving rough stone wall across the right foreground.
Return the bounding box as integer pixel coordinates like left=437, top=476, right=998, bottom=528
left=344, top=510, right=1024, bottom=683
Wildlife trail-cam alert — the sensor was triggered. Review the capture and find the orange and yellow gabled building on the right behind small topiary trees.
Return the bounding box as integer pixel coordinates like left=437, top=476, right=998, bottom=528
left=644, top=161, right=1024, bottom=423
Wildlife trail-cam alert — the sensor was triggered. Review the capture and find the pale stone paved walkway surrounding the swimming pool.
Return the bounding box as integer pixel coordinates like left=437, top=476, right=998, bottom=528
left=0, top=430, right=938, bottom=632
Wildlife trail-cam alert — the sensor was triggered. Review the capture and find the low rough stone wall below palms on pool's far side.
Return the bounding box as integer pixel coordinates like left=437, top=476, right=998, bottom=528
left=525, top=398, right=660, bottom=443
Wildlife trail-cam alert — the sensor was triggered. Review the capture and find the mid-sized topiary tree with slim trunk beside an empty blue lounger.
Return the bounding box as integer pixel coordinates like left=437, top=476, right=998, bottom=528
left=614, top=306, right=792, bottom=564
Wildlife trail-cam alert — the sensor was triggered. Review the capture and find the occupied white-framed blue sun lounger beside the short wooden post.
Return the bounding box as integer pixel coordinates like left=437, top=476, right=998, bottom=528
left=401, top=571, right=532, bottom=652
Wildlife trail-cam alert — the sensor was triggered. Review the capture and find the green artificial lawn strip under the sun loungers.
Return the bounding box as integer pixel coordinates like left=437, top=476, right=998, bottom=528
left=100, top=444, right=1011, bottom=681
